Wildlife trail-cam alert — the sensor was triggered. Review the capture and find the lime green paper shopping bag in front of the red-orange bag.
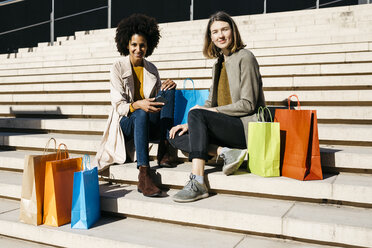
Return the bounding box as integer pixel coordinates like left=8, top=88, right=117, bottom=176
left=248, top=107, right=280, bottom=177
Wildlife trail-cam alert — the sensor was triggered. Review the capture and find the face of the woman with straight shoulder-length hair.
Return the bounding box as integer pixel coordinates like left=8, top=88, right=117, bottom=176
left=210, top=21, right=232, bottom=55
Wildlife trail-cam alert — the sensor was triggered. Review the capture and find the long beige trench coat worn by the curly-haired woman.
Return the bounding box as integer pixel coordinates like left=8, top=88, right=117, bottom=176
left=93, top=56, right=161, bottom=169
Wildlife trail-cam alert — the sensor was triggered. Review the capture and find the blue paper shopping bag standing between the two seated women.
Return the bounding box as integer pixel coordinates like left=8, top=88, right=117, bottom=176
left=174, top=78, right=209, bottom=125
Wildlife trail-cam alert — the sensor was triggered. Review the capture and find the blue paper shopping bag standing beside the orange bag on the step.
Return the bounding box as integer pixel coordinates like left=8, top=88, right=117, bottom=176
left=71, top=155, right=101, bottom=229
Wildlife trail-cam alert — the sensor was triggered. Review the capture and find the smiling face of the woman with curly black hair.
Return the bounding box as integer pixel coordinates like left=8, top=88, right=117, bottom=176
left=128, top=34, right=147, bottom=66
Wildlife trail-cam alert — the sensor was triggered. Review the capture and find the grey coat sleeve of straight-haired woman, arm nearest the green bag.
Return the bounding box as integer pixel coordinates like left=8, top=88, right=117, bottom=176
left=217, top=54, right=262, bottom=116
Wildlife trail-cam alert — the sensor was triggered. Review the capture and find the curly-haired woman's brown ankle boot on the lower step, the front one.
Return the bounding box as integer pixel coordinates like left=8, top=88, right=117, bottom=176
left=137, top=166, right=161, bottom=196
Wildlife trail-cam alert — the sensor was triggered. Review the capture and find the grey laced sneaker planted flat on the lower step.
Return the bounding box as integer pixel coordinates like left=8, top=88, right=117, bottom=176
left=173, top=174, right=209, bottom=202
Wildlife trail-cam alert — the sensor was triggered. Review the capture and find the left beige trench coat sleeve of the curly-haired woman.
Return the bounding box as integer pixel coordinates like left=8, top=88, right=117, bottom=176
left=110, top=63, right=131, bottom=116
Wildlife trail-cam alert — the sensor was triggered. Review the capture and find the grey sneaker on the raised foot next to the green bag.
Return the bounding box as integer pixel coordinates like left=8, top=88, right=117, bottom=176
left=219, top=147, right=247, bottom=175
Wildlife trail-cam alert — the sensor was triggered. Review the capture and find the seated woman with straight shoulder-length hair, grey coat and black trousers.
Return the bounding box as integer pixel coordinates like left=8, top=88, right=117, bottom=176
left=169, top=12, right=265, bottom=202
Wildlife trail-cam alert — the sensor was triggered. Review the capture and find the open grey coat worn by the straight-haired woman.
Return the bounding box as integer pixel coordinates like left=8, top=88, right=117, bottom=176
left=204, top=49, right=265, bottom=145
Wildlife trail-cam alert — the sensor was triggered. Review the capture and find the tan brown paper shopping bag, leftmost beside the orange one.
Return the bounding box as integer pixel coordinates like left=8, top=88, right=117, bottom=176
left=19, top=138, right=67, bottom=225
